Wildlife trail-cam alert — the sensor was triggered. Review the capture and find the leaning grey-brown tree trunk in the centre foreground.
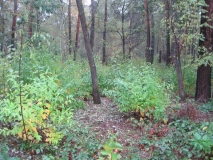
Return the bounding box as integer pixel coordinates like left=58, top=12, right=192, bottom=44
left=76, top=0, right=101, bottom=104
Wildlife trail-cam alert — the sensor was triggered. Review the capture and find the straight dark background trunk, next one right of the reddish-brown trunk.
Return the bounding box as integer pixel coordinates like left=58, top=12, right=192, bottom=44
left=165, top=0, right=171, bottom=65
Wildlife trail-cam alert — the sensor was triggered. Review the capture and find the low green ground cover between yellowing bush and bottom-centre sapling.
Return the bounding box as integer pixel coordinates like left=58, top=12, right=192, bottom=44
left=40, top=122, right=102, bottom=160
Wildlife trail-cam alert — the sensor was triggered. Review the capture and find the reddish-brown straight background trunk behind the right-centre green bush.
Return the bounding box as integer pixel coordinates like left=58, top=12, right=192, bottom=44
left=144, top=0, right=151, bottom=62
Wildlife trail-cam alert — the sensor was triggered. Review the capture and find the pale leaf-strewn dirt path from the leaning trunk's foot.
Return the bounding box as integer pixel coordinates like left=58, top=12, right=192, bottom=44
left=74, top=98, right=151, bottom=159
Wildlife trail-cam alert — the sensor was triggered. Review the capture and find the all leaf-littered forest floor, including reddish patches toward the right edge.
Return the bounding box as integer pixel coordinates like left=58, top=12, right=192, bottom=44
left=0, top=97, right=213, bottom=159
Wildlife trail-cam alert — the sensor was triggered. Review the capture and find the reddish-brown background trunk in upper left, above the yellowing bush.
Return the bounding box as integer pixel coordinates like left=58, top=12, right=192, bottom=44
left=11, top=0, right=18, bottom=51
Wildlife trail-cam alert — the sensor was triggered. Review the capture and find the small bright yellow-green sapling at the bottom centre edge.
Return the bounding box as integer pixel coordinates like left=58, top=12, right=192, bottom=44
left=99, top=135, right=123, bottom=160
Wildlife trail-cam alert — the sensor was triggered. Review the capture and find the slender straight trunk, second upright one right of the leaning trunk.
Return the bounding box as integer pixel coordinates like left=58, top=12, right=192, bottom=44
left=102, top=0, right=107, bottom=64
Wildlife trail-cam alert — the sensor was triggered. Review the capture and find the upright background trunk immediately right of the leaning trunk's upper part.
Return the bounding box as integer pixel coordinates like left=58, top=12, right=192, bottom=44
left=90, top=0, right=95, bottom=52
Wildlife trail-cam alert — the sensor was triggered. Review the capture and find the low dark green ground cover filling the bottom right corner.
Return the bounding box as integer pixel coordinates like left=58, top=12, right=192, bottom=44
left=140, top=120, right=213, bottom=160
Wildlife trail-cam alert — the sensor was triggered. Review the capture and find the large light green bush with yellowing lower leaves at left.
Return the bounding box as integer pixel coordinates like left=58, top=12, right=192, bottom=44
left=0, top=72, right=78, bottom=144
